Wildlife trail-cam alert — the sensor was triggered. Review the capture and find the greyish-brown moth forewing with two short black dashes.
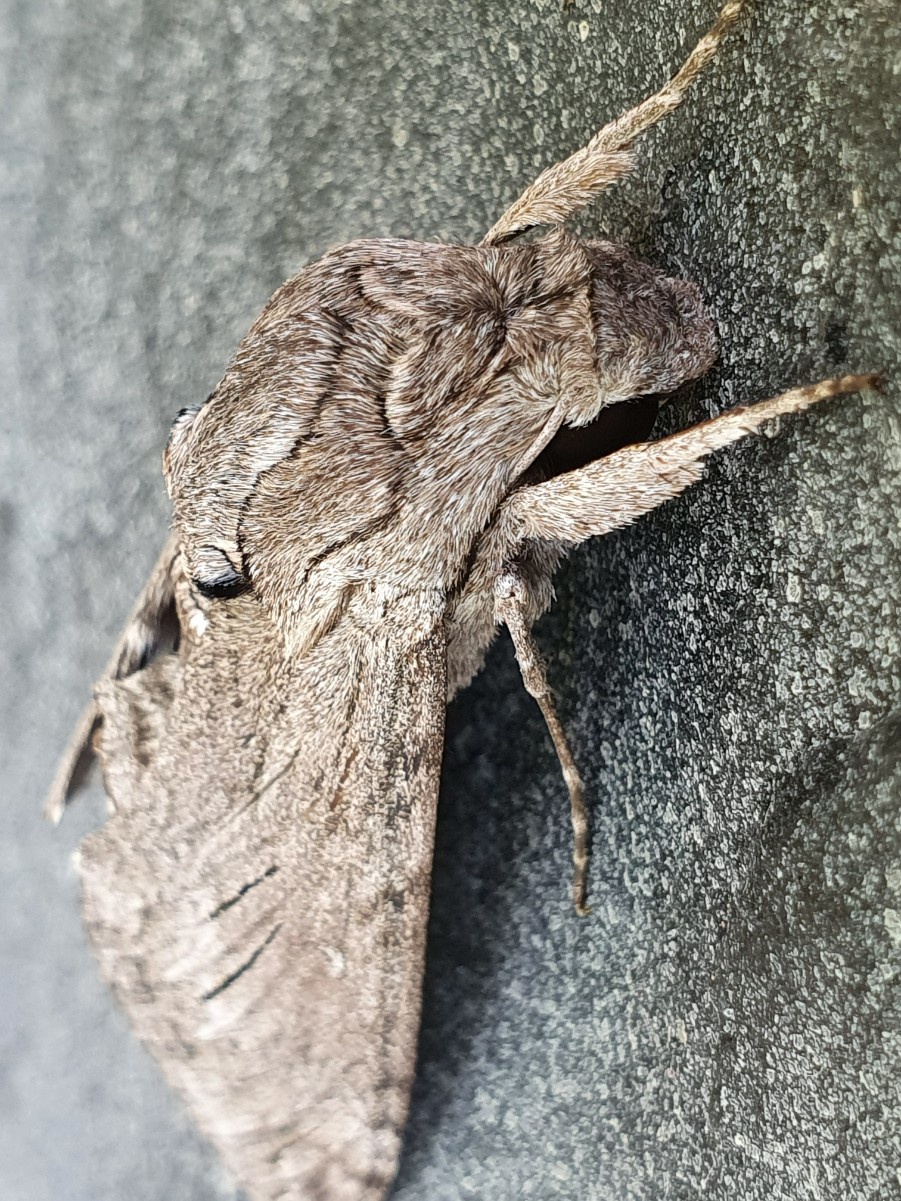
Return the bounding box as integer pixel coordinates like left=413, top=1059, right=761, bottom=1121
left=80, top=597, right=446, bottom=1201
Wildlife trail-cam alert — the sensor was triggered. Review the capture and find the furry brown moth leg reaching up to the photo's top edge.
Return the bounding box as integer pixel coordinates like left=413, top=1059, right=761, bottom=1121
left=482, top=0, right=746, bottom=246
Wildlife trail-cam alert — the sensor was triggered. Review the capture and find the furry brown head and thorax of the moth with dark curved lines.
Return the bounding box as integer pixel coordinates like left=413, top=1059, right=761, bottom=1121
left=158, top=231, right=716, bottom=644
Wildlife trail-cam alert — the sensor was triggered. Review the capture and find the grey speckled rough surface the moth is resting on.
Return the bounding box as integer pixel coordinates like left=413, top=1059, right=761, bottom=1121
left=0, top=0, right=901, bottom=1201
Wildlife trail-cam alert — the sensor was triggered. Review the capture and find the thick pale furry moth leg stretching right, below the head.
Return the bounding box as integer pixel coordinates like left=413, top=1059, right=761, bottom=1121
left=501, top=375, right=879, bottom=545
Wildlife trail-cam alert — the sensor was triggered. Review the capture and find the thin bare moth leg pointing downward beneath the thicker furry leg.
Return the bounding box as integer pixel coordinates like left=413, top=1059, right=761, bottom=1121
left=494, top=566, right=589, bottom=916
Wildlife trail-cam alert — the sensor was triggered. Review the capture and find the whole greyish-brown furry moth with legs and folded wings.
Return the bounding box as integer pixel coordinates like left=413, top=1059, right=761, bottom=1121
left=49, top=0, right=876, bottom=1201
